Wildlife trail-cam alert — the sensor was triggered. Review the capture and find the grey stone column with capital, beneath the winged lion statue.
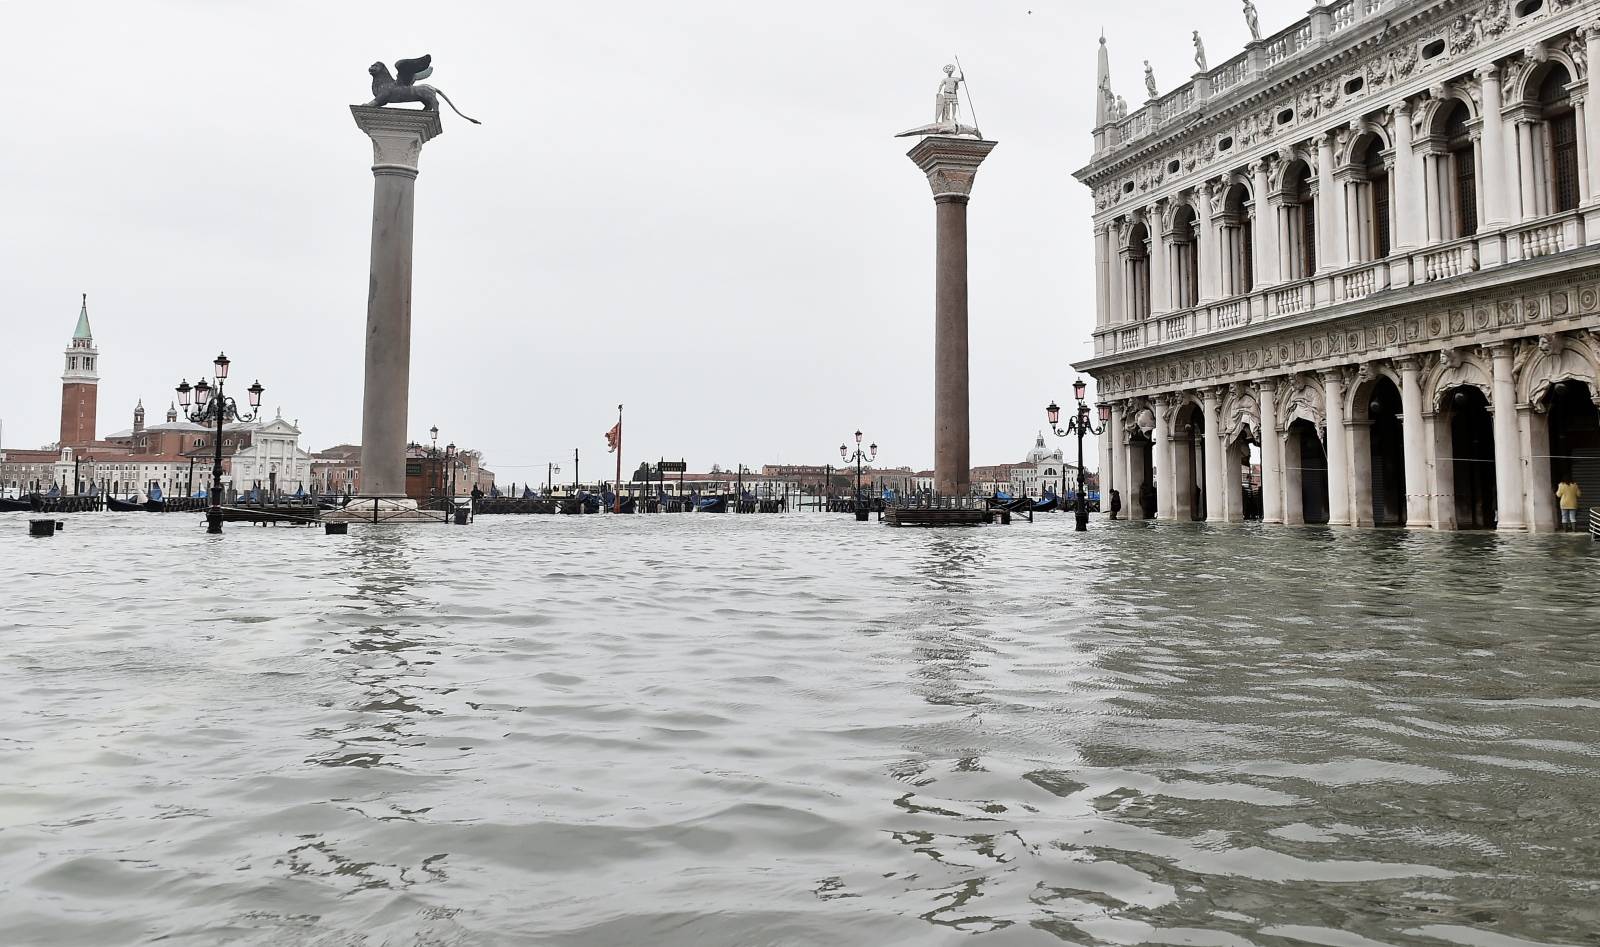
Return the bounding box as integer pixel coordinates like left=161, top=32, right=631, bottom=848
left=350, top=106, right=443, bottom=501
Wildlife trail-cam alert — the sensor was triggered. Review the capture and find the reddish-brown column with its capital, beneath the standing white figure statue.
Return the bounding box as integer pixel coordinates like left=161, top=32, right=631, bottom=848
left=906, top=134, right=995, bottom=496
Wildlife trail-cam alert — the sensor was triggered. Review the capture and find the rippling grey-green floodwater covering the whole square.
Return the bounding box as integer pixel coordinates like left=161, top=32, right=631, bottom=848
left=0, top=513, right=1600, bottom=947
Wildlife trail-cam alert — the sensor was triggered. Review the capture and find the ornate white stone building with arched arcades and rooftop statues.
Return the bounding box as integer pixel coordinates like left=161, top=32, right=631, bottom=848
left=1077, top=0, right=1600, bottom=531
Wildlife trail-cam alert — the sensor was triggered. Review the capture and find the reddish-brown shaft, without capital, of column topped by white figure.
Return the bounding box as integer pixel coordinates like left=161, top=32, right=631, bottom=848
left=933, top=194, right=971, bottom=496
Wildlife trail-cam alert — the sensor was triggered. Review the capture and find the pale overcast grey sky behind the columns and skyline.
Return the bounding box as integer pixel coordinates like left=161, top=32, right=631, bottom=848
left=0, top=0, right=1260, bottom=481
